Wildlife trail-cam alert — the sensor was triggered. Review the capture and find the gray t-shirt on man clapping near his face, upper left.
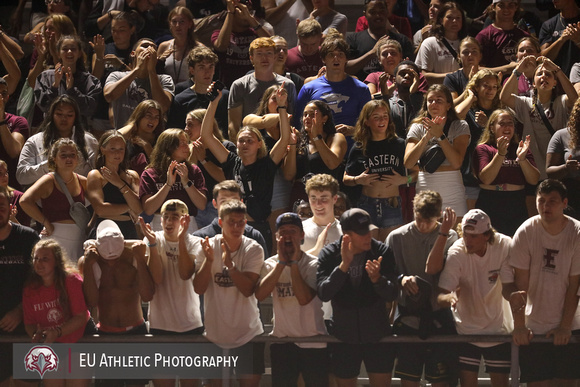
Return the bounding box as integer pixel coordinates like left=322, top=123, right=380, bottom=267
left=105, top=71, right=175, bottom=129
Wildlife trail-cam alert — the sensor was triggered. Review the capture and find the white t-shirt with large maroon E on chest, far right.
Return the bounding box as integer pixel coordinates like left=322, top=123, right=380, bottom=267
left=509, top=215, right=580, bottom=335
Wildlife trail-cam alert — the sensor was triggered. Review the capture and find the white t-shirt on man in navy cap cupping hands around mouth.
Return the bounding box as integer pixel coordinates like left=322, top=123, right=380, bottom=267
left=261, top=253, right=326, bottom=348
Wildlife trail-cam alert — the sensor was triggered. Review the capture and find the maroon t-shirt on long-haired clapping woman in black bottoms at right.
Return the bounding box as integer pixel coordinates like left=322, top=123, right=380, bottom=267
left=473, top=144, right=536, bottom=185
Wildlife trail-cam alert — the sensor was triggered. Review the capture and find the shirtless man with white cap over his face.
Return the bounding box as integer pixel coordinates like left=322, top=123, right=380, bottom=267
left=81, top=220, right=155, bottom=386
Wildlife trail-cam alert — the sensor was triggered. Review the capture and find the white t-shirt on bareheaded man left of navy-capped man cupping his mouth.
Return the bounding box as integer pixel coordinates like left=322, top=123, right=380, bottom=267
left=195, top=234, right=264, bottom=348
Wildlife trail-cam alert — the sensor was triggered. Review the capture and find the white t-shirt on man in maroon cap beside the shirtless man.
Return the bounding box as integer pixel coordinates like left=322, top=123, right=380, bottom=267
left=144, top=231, right=203, bottom=332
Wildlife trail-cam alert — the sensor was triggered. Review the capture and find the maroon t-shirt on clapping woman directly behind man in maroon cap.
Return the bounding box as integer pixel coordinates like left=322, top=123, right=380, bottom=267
left=139, top=165, right=207, bottom=216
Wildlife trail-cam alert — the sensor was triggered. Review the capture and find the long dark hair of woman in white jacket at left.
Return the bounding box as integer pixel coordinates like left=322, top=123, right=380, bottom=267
left=39, top=94, right=89, bottom=161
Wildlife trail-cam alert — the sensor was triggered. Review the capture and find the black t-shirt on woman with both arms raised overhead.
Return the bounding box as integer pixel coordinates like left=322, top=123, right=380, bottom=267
left=222, top=152, right=278, bottom=222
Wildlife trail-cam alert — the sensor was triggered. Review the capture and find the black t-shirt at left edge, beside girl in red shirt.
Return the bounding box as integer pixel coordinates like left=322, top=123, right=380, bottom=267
left=0, top=223, right=39, bottom=322
